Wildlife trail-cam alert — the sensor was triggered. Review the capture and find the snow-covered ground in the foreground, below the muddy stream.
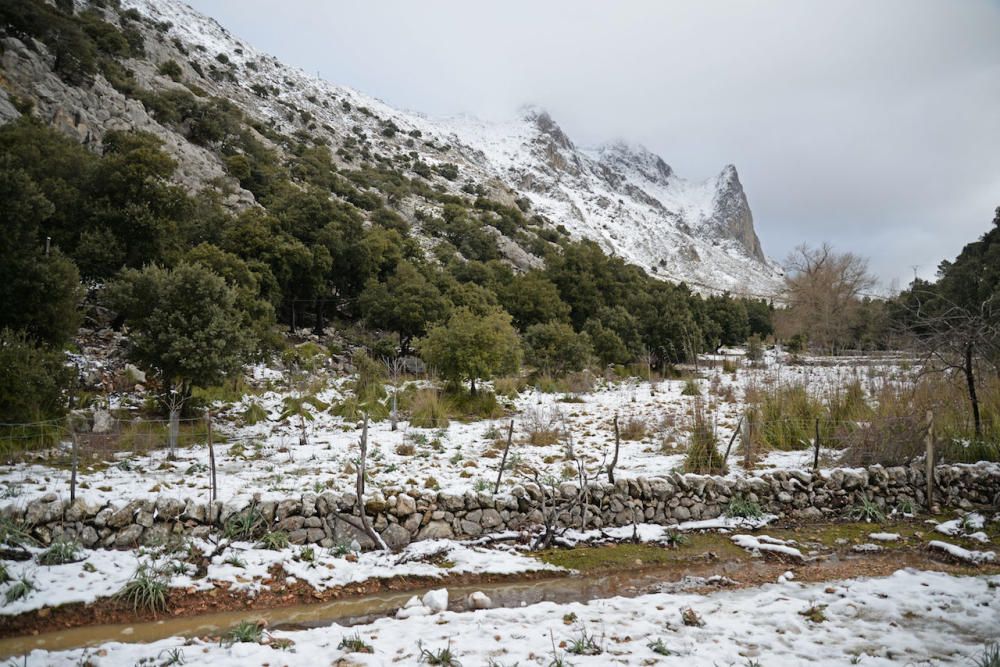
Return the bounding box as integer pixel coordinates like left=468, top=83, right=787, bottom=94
left=18, top=570, right=1000, bottom=667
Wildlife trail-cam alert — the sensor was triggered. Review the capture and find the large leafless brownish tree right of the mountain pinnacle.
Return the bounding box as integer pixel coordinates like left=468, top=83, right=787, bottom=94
left=778, top=243, right=876, bottom=352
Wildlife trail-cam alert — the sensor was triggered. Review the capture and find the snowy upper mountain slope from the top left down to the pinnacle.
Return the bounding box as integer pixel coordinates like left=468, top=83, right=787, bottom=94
left=122, top=0, right=781, bottom=296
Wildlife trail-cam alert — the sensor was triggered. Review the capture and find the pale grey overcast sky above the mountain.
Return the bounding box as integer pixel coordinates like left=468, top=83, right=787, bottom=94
left=189, top=0, right=1000, bottom=292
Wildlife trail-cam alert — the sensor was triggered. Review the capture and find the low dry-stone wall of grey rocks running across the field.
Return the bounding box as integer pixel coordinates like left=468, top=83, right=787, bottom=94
left=0, top=464, right=1000, bottom=549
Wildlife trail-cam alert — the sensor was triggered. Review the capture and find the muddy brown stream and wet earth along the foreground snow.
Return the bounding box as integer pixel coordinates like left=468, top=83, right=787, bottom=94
left=0, top=531, right=1000, bottom=660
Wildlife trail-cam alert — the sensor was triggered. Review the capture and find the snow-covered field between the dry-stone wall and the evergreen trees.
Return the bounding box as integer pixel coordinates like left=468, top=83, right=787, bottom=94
left=0, top=353, right=905, bottom=505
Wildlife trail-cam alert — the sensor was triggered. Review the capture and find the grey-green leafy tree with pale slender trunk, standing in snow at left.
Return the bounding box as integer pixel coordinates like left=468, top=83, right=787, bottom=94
left=108, top=263, right=254, bottom=452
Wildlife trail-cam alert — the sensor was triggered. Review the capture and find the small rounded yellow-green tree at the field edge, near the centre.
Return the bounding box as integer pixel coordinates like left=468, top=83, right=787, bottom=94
left=417, top=308, right=521, bottom=395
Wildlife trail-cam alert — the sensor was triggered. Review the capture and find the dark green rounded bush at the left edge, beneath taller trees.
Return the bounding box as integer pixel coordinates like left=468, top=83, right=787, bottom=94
left=0, top=329, right=76, bottom=422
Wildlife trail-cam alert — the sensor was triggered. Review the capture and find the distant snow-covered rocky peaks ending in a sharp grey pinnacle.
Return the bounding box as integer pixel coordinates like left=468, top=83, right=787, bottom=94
left=435, top=107, right=781, bottom=294
